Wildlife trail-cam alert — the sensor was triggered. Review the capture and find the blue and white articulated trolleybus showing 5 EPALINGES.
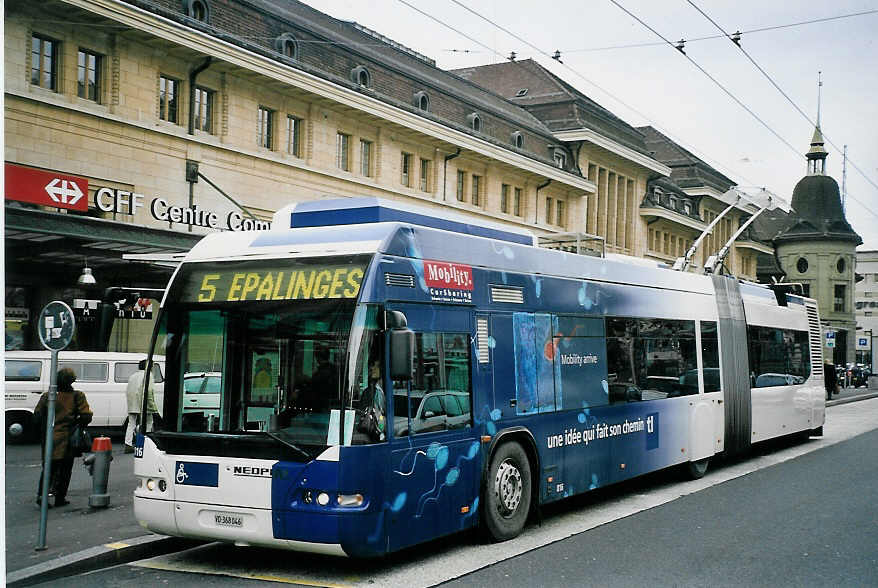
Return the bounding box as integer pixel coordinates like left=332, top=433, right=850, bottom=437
left=134, top=198, right=825, bottom=557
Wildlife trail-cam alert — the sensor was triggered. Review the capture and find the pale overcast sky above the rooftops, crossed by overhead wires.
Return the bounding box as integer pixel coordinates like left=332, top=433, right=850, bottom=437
left=305, top=0, right=878, bottom=250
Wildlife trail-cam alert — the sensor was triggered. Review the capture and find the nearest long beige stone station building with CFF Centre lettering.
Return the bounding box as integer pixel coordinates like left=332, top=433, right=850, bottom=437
left=4, top=0, right=597, bottom=351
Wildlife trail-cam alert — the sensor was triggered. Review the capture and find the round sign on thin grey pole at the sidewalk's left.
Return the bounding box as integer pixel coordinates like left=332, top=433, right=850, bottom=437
left=36, top=300, right=76, bottom=551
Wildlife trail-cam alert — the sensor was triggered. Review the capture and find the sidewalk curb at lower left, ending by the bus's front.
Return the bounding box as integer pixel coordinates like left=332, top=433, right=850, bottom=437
left=6, top=535, right=202, bottom=586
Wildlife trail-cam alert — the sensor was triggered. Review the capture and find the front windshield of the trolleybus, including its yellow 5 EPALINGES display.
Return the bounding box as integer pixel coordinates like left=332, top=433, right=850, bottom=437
left=154, top=258, right=385, bottom=458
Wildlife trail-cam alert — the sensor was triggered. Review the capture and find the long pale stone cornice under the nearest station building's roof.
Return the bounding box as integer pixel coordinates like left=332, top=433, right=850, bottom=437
left=63, top=0, right=597, bottom=193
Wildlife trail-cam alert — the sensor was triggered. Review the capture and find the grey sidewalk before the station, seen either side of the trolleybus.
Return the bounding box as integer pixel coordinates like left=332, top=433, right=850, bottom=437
left=6, top=377, right=878, bottom=586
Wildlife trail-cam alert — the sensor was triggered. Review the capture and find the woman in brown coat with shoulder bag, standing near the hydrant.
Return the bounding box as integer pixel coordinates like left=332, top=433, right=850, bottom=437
left=34, top=368, right=92, bottom=506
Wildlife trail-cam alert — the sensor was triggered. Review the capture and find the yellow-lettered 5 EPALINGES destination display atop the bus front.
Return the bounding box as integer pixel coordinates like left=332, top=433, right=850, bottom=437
left=182, top=262, right=365, bottom=303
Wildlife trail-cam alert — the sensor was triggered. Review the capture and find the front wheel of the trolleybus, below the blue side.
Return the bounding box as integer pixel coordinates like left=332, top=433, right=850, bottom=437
left=482, top=441, right=531, bottom=542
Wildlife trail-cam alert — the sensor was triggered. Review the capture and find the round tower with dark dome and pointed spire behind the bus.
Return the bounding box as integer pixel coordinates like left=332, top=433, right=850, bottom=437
left=774, top=123, right=863, bottom=364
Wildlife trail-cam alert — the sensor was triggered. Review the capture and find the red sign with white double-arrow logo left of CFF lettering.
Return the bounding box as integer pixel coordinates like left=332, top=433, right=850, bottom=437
left=6, top=163, right=88, bottom=211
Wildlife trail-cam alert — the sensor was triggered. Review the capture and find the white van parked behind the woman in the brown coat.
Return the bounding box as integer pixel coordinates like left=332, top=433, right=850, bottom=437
left=5, top=351, right=165, bottom=442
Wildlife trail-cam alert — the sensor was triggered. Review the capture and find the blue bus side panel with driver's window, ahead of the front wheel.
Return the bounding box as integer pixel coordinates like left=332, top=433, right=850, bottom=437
left=386, top=304, right=480, bottom=549
